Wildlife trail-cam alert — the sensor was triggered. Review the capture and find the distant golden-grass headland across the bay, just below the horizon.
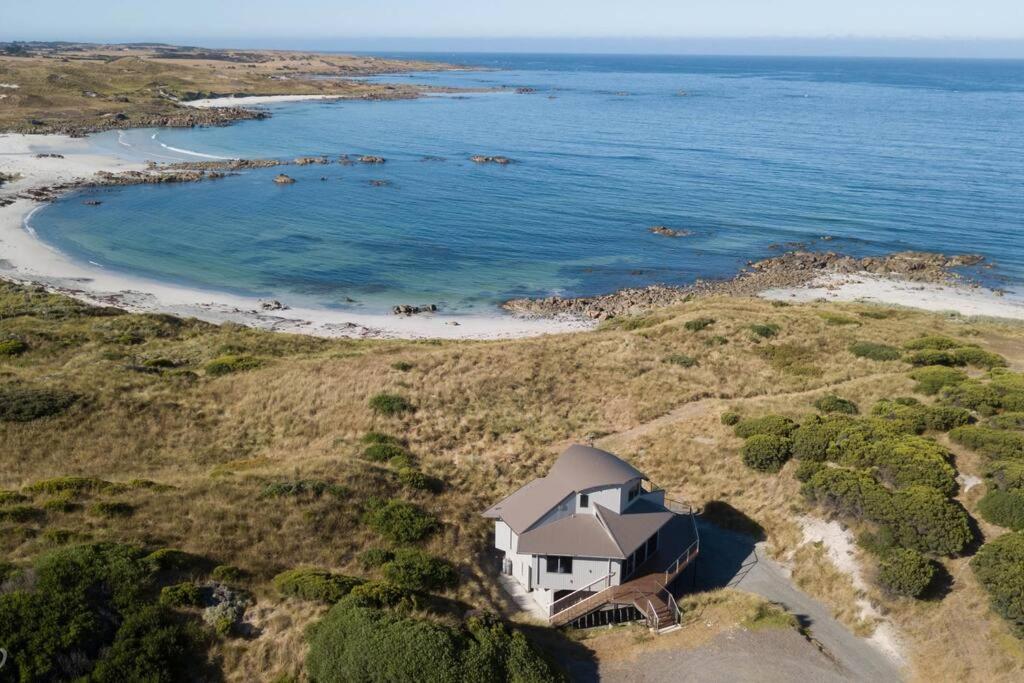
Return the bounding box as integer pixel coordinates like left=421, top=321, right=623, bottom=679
left=0, top=45, right=444, bottom=133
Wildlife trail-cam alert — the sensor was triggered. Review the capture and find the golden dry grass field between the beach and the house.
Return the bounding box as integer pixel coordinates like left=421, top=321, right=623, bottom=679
left=0, top=285, right=1024, bottom=681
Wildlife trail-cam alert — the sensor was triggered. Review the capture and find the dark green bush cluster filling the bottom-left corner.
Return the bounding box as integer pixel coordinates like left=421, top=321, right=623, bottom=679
left=0, top=544, right=205, bottom=681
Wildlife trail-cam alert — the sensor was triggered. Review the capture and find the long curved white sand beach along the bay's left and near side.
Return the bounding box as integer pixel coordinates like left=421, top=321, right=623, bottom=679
left=0, top=135, right=593, bottom=339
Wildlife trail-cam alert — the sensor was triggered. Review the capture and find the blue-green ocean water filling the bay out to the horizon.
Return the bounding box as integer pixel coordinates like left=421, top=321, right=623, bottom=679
left=31, top=53, right=1024, bottom=312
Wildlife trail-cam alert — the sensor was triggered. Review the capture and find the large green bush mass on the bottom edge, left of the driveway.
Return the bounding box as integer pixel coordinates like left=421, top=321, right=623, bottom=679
left=306, top=598, right=561, bottom=683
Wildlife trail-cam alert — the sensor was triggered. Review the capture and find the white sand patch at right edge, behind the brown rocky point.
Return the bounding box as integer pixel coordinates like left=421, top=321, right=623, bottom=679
left=761, top=272, right=1024, bottom=319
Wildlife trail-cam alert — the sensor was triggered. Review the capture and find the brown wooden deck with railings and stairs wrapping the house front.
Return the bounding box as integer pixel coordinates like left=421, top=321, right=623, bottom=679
left=550, top=515, right=699, bottom=628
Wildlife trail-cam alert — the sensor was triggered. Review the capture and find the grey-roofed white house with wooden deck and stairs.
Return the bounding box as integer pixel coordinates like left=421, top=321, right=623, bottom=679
left=483, top=445, right=699, bottom=626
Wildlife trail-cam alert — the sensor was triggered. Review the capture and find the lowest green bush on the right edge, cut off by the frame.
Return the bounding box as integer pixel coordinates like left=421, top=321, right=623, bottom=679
left=971, top=532, right=1024, bottom=638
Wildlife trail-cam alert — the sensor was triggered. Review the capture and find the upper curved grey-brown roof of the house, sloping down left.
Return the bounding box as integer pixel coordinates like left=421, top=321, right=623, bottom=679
left=483, top=445, right=646, bottom=535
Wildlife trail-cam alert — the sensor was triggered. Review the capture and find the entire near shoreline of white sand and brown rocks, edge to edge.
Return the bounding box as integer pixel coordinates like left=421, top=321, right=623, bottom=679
left=0, top=133, right=1024, bottom=340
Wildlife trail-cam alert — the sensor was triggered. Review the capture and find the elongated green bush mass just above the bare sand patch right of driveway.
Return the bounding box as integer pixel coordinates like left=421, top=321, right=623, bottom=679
left=803, top=467, right=974, bottom=556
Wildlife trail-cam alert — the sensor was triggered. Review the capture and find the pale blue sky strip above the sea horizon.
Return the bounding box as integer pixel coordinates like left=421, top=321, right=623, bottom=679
left=6, top=0, right=1024, bottom=56
